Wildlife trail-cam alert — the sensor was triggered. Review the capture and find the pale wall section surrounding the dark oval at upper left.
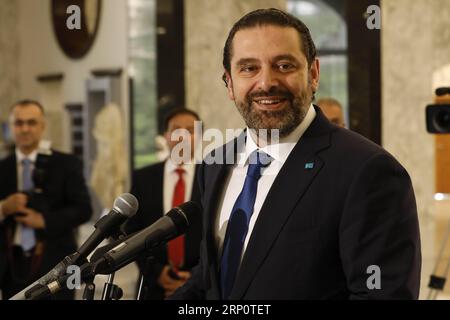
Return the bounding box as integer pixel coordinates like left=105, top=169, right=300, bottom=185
left=16, top=0, right=129, bottom=152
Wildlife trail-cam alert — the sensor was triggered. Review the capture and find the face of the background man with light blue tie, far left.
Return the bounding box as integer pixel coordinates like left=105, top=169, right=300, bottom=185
left=10, top=104, right=45, bottom=154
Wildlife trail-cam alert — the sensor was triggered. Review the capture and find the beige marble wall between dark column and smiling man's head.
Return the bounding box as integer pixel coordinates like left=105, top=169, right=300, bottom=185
left=185, top=0, right=286, bottom=136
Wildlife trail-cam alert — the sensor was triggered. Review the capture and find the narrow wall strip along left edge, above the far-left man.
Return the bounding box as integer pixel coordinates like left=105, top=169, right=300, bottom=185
left=0, top=0, right=19, bottom=122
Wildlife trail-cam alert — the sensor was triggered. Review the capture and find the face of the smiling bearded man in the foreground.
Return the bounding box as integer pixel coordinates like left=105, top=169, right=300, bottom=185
left=226, top=25, right=319, bottom=137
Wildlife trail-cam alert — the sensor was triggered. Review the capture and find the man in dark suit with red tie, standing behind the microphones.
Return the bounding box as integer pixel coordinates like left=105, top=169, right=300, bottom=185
left=125, top=108, right=202, bottom=300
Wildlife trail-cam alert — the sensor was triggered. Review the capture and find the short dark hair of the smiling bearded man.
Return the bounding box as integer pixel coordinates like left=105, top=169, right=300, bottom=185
left=222, top=8, right=317, bottom=85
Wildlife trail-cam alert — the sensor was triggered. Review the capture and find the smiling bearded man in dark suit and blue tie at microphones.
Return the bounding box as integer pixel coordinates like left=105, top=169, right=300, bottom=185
left=171, top=9, right=421, bottom=299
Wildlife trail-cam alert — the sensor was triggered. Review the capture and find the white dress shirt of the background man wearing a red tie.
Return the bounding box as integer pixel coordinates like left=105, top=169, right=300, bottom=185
left=163, top=158, right=195, bottom=213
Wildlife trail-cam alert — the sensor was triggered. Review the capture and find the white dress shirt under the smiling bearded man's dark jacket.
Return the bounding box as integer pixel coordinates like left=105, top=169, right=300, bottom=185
left=214, top=105, right=316, bottom=261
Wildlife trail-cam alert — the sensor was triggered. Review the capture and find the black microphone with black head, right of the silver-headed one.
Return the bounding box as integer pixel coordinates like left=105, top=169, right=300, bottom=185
left=92, top=201, right=201, bottom=274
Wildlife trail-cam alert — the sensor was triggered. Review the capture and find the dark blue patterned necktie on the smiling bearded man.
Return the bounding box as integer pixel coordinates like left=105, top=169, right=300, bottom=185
left=220, top=151, right=272, bottom=299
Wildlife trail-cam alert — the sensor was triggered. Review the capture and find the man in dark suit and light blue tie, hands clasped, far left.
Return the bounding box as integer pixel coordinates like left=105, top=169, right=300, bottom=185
left=0, top=100, right=92, bottom=299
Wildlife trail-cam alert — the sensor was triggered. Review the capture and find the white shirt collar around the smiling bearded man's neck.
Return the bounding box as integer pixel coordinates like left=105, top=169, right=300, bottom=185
left=238, top=104, right=316, bottom=166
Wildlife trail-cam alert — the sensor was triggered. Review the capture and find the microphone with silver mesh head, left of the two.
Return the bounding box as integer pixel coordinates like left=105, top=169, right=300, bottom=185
left=10, top=193, right=139, bottom=300
